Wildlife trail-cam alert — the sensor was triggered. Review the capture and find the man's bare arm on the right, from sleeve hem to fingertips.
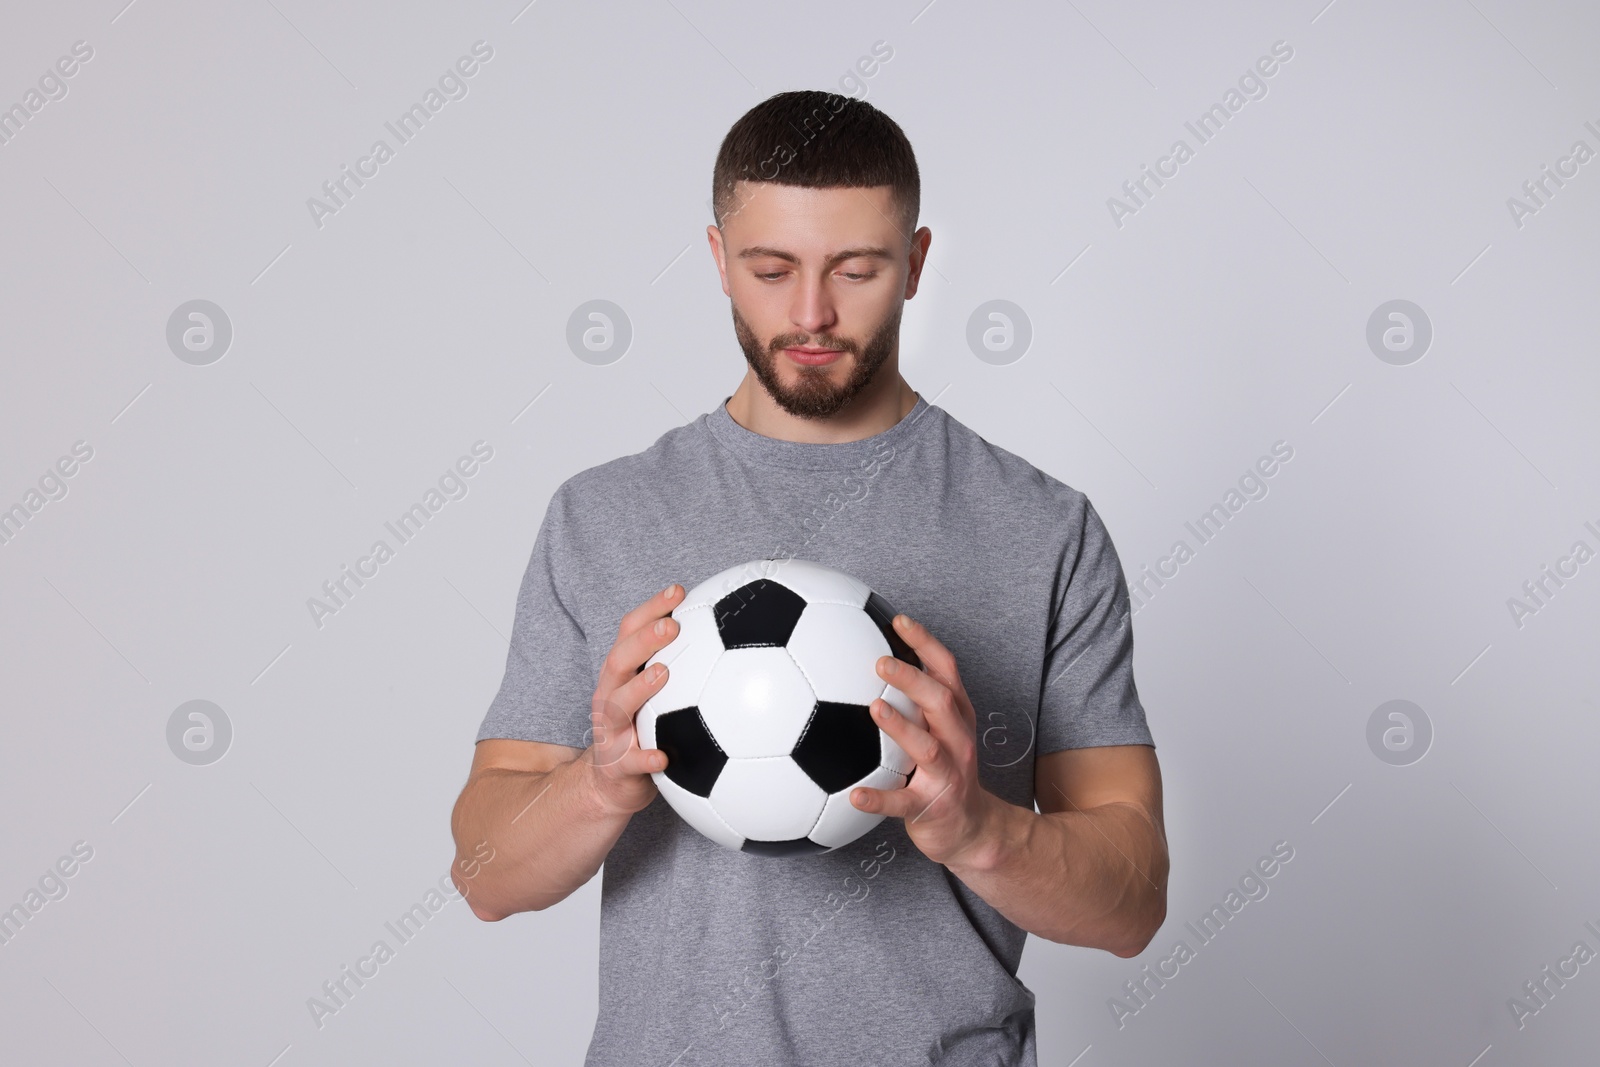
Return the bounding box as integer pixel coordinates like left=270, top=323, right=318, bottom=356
left=851, top=614, right=1168, bottom=957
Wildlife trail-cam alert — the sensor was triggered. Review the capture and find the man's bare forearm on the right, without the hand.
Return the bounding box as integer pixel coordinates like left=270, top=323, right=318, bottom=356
left=949, top=793, right=1168, bottom=957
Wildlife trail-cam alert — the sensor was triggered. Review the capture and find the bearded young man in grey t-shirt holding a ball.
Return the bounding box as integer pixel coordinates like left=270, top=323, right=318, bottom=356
left=451, top=93, right=1168, bottom=1067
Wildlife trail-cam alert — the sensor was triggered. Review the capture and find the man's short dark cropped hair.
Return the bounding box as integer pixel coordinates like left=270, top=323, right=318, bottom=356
left=712, top=90, right=922, bottom=240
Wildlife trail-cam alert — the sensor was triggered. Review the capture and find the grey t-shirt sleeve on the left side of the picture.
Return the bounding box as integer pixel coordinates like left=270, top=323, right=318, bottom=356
left=477, top=485, right=595, bottom=749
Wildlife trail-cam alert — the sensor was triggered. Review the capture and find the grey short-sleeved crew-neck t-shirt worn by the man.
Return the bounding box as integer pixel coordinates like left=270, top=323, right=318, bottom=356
left=478, top=397, right=1152, bottom=1067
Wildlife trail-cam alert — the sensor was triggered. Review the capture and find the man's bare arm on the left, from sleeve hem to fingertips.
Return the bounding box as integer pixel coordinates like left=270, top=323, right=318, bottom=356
left=450, top=584, right=683, bottom=921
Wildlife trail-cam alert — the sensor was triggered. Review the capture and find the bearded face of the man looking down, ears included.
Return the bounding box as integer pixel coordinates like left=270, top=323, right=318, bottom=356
left=709, top=181, right=926, bottom=419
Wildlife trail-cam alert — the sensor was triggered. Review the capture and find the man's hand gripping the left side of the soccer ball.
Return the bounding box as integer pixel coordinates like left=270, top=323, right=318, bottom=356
left=582, top=582, right=683, bottom=814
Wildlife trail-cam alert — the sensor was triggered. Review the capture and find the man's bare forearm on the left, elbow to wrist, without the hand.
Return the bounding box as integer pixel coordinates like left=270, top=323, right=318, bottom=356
left=450, top=750, right=630, bottom=920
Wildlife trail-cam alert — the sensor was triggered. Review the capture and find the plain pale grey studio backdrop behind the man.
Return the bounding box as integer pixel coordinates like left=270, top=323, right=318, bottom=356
left=0, top=0, right=1600, bottom=1067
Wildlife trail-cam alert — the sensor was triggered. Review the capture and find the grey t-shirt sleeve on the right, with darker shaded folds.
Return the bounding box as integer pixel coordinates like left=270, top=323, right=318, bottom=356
left=1038, top=498, right=1155, bottom=755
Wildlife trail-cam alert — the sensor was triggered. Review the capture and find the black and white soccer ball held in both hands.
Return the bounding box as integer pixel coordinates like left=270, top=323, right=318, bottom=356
left=634, top=558, right=923, bottom=856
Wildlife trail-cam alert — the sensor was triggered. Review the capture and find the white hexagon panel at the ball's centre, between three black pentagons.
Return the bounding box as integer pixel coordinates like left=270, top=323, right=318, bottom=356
left=699, top=648, right=816, bottom=758
